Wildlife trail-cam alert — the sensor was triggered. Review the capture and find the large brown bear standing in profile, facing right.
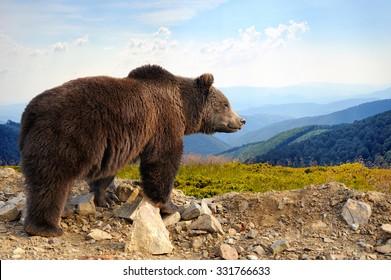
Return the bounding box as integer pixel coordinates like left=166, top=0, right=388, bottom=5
left=18, top=65, right=246, bottom=237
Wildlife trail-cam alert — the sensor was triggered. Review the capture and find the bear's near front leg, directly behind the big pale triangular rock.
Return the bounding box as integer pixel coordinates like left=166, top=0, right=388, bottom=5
left=140, top=143, right=182, bottom=214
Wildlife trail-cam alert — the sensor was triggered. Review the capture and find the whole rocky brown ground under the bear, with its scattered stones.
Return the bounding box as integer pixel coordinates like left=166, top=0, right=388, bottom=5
left=0, top=166, right=391, bottom=260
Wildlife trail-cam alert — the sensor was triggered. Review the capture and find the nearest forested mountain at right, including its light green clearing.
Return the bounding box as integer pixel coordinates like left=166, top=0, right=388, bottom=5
left=222, top=110, right=391, bottom=167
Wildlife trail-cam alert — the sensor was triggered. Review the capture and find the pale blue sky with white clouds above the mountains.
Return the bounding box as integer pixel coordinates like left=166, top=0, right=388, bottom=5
left=0, top=0, right=391, bottom=104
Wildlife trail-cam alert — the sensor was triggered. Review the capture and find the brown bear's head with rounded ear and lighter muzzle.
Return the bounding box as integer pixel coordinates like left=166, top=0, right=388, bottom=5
left=196, top=74, right=246, bottom=134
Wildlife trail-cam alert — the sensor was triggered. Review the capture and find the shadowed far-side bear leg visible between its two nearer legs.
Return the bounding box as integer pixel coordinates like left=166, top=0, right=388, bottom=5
left=88, top=176, right=119, bottom=207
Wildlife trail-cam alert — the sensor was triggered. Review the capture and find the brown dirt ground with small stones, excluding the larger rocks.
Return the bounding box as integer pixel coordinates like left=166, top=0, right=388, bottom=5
left=0, top=166, right=391, bottom=260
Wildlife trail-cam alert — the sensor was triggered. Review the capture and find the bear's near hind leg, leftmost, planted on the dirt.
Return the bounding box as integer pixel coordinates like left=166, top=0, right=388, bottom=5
left=24, top=181, right=72, bottom=237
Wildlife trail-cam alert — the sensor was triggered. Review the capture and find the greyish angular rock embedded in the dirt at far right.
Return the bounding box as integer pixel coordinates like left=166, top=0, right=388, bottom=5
left=342, top=199, right=372, bottom=229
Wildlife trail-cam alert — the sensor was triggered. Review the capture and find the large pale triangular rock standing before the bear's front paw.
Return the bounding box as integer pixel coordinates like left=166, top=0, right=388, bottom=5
left=125, top=198, right=174, bottom=255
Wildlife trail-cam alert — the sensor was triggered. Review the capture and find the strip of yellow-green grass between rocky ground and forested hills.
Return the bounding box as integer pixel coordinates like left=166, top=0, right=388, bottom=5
left=117, top=162, right=391, bottom=197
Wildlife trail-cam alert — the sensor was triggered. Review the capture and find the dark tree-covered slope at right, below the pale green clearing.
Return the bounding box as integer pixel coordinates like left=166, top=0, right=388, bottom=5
left=253, top=111, right=391, bottom=167
